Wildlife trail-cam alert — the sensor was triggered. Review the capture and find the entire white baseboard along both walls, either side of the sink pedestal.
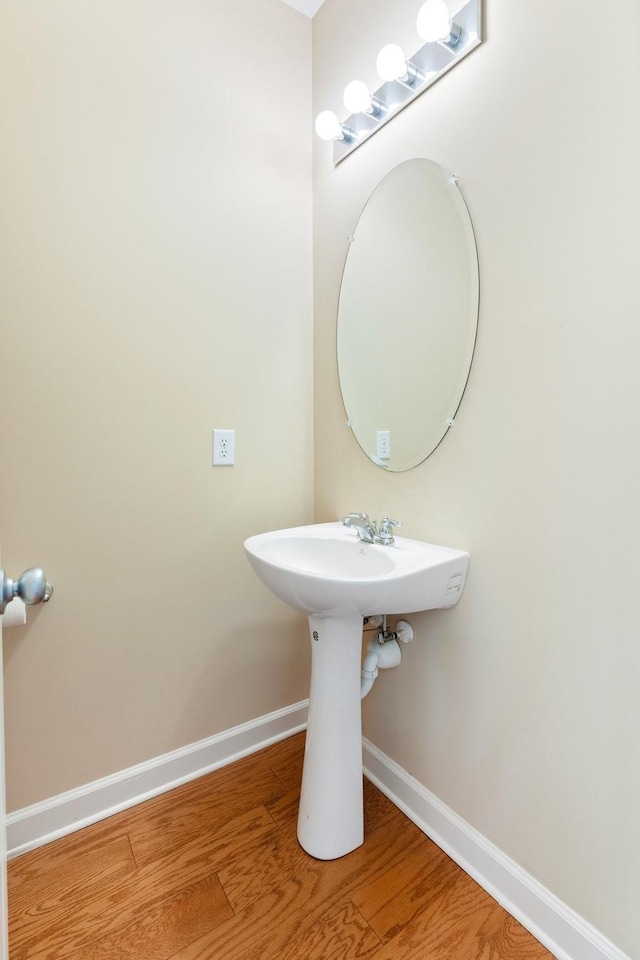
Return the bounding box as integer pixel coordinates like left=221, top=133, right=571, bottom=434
left=7, top=712, right=630, bottom=960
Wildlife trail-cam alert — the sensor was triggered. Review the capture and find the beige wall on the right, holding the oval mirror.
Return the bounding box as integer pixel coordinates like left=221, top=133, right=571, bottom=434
left=314, top=0, right=640, bottom=956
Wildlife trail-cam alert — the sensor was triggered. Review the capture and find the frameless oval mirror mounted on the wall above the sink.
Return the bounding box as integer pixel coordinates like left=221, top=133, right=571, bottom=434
left=337, top=159, right=479, bottom=471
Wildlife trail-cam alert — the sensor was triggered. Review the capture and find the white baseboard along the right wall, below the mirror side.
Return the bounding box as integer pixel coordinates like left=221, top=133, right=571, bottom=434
left=363, top=740, right=630, bottom=960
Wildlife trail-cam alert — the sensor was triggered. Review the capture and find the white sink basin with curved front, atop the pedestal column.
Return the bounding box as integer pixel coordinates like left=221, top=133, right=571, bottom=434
left=244, top=523, right=469, bottom=617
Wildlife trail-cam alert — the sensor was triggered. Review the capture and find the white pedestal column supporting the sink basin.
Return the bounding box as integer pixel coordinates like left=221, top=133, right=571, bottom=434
left=298, top=615, right=364, bottom=860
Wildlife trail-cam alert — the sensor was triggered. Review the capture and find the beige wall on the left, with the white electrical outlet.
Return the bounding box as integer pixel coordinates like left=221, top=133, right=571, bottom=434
left=0, top=0, right=313, bottom=809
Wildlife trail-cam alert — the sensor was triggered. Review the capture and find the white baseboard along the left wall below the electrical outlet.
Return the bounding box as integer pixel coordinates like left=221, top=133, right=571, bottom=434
left=7, top=700, right=309, bottom=859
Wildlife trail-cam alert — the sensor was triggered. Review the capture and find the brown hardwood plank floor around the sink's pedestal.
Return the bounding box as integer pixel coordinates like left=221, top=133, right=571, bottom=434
left=9, top=734, right=552, bottom=960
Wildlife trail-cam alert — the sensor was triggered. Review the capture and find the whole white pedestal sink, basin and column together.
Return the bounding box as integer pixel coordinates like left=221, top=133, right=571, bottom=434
left=244, top=523, right=469, bottom=860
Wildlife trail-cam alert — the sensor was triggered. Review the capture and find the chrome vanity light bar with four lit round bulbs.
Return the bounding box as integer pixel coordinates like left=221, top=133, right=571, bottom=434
left=316, top=0, right=482, bottom=164
